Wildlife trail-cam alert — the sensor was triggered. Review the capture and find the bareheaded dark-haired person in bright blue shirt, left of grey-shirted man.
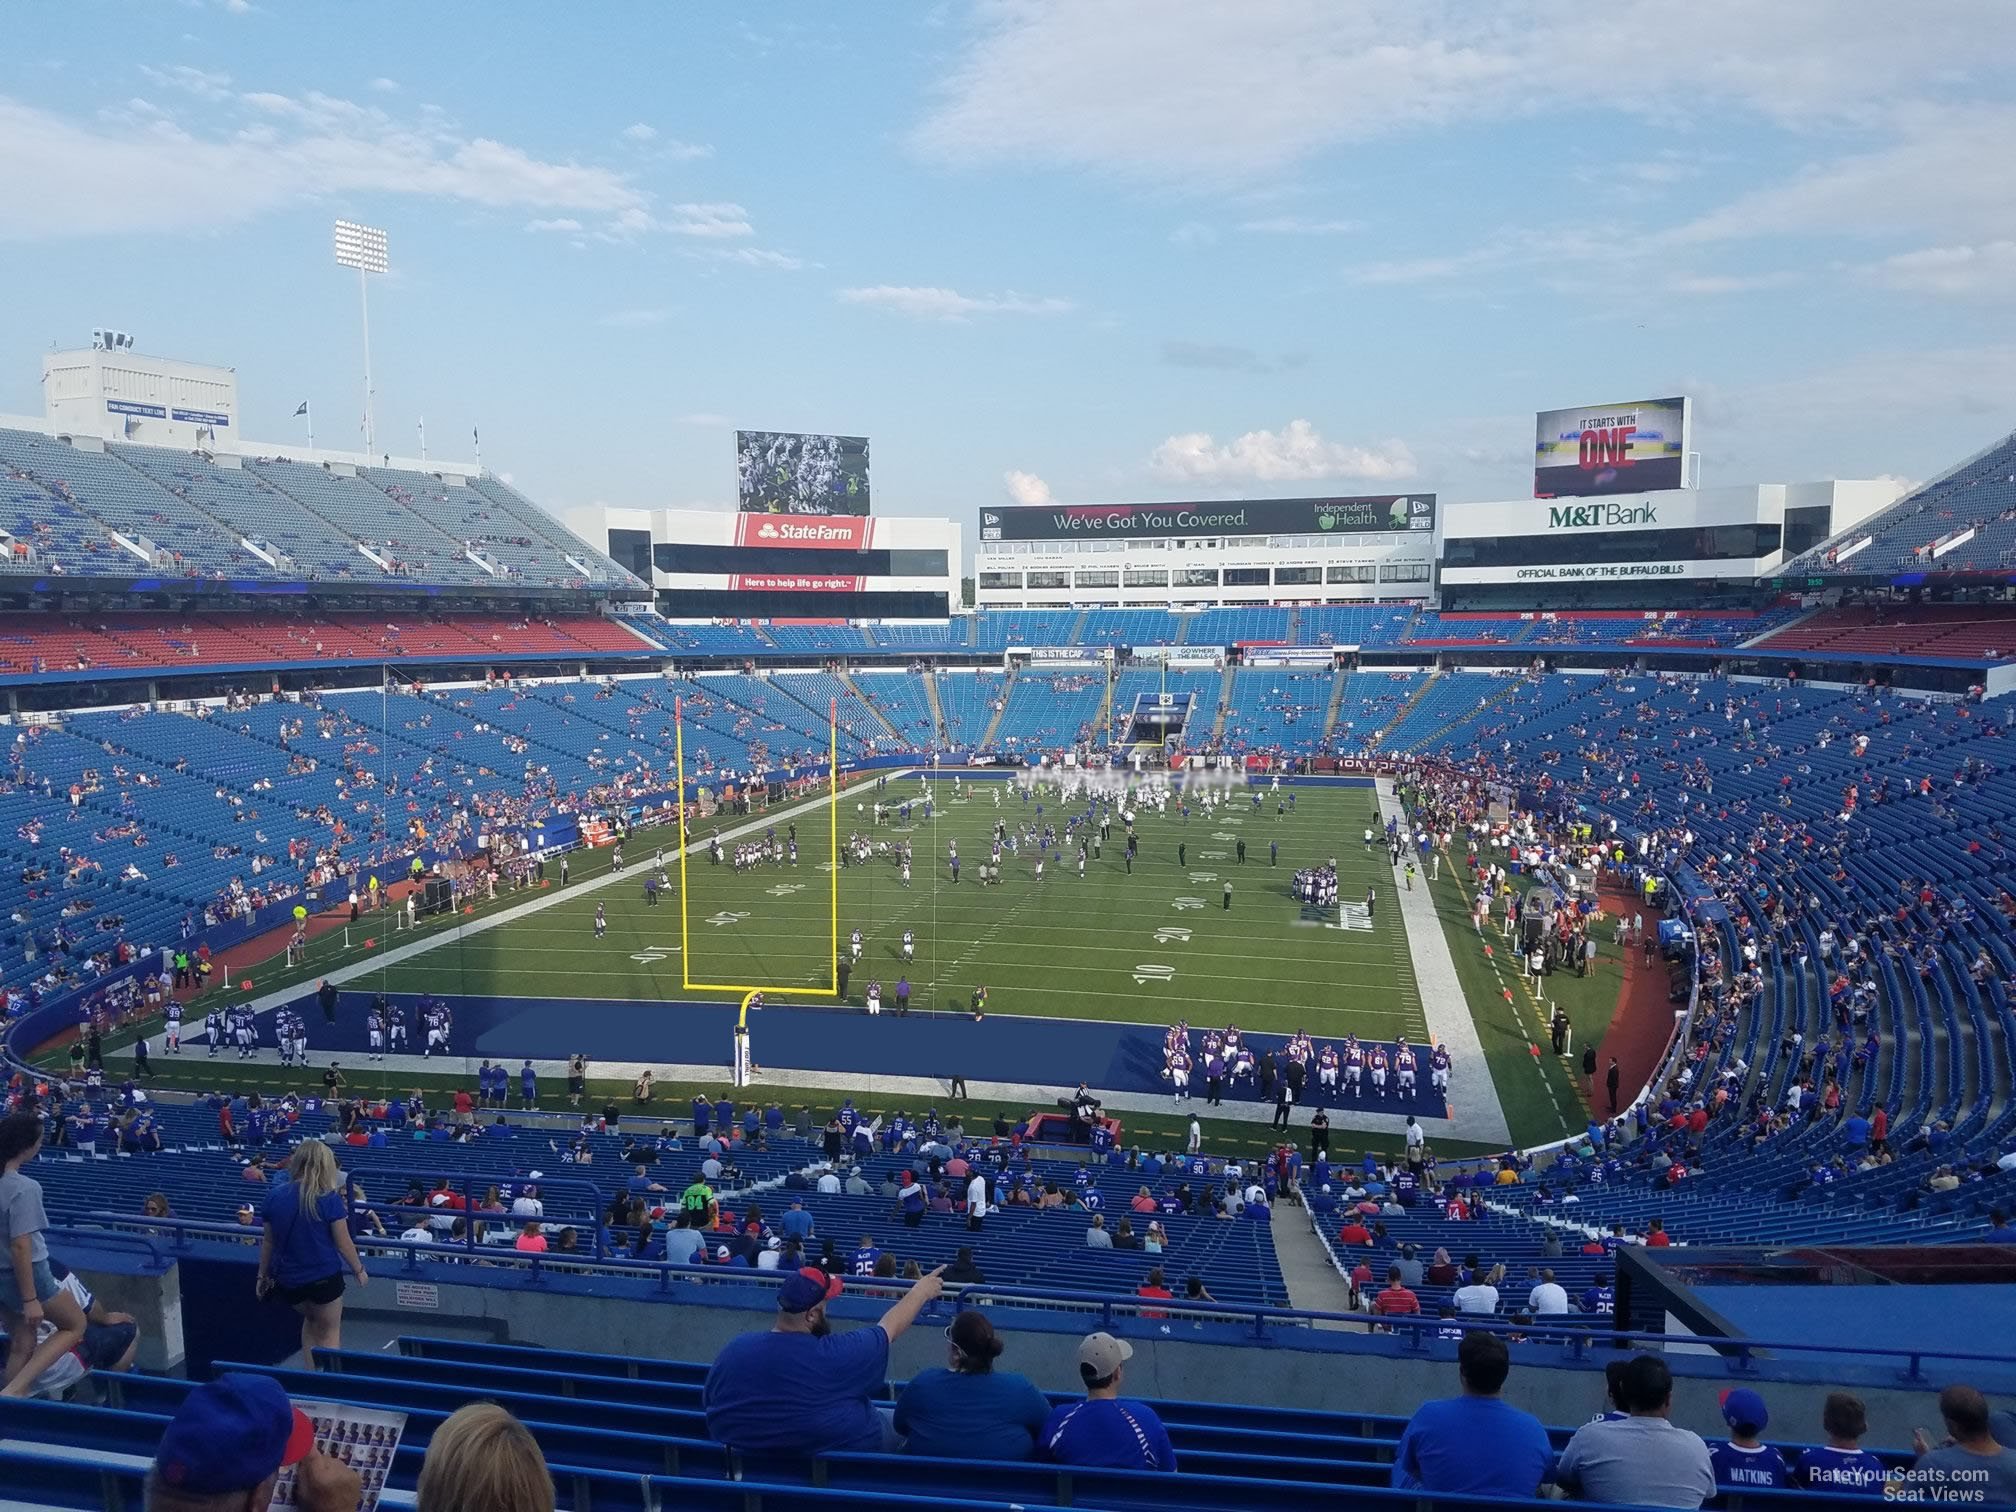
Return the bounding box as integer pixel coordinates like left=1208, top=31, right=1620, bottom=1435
left=1393, top=1329, right=1554, bottom=1500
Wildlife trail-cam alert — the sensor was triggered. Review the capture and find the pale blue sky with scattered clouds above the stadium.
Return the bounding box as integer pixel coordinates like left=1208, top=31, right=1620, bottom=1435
left=0, top=0, right=2016, bottom=544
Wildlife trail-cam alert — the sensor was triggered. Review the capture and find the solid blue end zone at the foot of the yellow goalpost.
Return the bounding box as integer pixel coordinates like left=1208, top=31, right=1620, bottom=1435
left=288, top=992, right=1447, bottom=1121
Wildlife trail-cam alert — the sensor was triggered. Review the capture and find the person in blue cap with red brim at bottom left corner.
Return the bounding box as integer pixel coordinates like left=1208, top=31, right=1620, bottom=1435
left=147, top=1375, right=363, bottom=1512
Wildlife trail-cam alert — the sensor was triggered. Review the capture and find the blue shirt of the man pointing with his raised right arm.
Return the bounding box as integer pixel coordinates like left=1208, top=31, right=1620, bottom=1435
left=700, top=1325, right=889, bottom=1458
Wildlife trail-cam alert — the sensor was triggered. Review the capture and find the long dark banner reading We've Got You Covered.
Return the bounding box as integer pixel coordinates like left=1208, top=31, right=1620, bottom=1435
left=980, top=494, right=1435, bottom=540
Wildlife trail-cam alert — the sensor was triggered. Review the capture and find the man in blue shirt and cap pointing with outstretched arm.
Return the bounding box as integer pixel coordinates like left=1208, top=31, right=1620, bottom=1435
left=702, top=1268, right=943, bottom=1456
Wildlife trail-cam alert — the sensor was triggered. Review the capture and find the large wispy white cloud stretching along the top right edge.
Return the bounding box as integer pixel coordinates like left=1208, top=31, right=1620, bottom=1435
left=913, top=0, right=2016, bottom=185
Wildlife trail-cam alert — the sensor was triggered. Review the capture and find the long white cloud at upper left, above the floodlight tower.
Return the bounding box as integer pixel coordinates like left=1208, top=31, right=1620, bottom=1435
left=0, top=93, right=649, bottom=240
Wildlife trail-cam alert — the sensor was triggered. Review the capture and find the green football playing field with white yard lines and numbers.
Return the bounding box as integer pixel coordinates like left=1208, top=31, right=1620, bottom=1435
left=362, top=778, right=1427, bottom=1040
